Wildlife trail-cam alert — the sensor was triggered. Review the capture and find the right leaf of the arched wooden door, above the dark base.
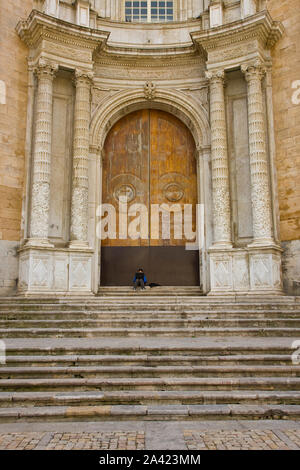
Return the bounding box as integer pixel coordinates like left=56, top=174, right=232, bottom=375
left=149, top=110, right=197, bottom=246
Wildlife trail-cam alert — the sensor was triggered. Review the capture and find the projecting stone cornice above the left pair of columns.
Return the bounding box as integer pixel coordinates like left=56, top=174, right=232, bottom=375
left=16, top=10, right=110, bottom=50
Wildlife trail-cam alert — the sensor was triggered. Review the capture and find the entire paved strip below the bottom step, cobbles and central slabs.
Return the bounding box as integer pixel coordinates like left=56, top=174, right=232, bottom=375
left=0, top=420, right=300, bottom=451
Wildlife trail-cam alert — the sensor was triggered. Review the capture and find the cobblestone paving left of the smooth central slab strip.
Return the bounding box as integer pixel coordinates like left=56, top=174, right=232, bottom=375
left=0, top=431, right=145, bottom=450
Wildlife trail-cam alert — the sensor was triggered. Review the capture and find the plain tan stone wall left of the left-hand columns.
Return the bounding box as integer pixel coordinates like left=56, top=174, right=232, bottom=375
left=0, top=0, right=33, bottom=294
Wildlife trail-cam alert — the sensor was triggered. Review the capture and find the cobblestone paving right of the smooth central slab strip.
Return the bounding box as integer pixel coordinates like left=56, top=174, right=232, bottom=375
left=184, top=430, right=300, bottom=450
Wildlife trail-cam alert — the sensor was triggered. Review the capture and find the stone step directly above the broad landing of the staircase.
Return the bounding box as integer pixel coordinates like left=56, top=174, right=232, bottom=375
left=0, top=326, right=300, bottom=338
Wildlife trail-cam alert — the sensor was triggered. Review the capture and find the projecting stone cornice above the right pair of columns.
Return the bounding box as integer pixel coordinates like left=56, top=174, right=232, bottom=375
left=191, top=10, right=284, bottom=52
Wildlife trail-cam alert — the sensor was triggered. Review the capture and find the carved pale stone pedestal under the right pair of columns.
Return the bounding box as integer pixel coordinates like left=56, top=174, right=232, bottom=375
left=208, top=243, right=284, bottom=296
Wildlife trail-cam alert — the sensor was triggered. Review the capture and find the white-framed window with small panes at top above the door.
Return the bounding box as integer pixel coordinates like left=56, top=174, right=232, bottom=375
left=125, top=0, right=174, bottom=22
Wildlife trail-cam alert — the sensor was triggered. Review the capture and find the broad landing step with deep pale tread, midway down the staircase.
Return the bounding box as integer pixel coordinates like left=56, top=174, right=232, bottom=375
left=6, top=344, right=294, bottom=359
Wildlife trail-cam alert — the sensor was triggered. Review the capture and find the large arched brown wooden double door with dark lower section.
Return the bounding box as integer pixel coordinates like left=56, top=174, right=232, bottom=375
left=101, top=110, right=199, bottom=286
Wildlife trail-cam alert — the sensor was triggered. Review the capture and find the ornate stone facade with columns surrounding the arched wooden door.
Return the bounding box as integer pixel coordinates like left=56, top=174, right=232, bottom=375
left=0, top=0, right=300, bottom=295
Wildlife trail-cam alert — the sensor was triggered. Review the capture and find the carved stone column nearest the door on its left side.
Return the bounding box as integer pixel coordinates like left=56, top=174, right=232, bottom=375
left=70, top=70, right=92, bottom=248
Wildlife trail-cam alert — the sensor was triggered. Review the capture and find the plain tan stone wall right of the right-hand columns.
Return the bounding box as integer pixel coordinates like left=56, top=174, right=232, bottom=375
left=267, top=0, right=300, bottom=293
